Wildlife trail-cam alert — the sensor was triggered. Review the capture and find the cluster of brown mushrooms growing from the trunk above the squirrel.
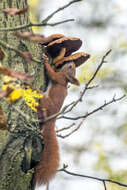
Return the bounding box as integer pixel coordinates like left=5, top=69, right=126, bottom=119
left=43, top=34, right=90, bottom=70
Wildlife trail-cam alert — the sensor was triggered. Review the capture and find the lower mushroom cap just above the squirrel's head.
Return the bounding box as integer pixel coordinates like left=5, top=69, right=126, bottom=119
left=55, top=52, right=90, bottom=69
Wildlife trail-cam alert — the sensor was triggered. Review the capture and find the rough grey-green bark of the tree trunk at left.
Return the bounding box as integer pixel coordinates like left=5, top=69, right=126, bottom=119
left=0, top=0, right=45, bottom=190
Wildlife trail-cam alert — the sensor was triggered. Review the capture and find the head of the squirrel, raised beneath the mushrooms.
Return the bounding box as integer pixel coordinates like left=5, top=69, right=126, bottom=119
left=60, top=61, right=80, bottom=86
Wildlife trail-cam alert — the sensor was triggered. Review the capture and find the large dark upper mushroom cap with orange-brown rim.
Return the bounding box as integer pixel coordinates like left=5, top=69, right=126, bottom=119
left=47, top=37, right=82, bottom=58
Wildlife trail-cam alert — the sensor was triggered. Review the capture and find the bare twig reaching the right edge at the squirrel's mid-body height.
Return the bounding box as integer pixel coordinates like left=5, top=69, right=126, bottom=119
left=58, top=95, right=126, bottom=120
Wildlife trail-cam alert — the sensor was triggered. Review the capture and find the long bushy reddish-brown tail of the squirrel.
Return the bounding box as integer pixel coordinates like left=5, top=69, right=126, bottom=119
left=35, top=121, right=59, bottom=185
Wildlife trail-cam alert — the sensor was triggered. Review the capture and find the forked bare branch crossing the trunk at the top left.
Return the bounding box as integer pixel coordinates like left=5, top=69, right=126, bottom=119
left=0, top=0, right=82, bottom=32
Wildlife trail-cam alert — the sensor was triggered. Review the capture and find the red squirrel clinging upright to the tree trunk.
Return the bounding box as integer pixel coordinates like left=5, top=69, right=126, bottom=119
left=35, top=55, right=79, bottom=186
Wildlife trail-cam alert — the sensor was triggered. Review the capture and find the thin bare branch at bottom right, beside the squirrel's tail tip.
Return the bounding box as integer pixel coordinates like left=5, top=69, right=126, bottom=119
left=58, top=164, right=127, bottom=190
